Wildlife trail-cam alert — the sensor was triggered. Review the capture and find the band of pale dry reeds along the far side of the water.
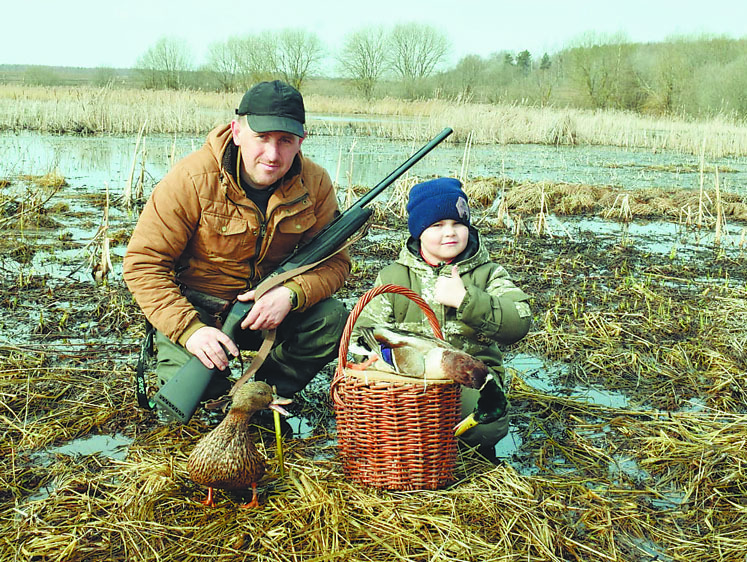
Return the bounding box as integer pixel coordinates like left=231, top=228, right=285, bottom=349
left=0, top=85, right=747, bottom=158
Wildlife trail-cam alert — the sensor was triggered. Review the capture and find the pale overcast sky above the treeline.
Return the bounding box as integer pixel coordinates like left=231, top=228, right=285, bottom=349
left=5, top=0, right=747, bottom=68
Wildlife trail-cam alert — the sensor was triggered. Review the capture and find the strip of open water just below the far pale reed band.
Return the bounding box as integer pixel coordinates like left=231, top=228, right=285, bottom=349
left=0, top=132, right=747, bottom=193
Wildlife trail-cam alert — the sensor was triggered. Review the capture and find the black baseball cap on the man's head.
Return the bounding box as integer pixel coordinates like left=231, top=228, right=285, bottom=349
left=236, top=80, right=306, bottom=138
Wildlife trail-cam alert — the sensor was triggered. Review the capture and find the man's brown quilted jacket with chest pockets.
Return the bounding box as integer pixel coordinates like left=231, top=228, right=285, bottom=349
left=124, top=125, right=350, bottom=344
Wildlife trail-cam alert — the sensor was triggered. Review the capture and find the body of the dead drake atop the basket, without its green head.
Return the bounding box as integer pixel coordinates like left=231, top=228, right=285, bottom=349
left=350, top=327, right=489, bottom=388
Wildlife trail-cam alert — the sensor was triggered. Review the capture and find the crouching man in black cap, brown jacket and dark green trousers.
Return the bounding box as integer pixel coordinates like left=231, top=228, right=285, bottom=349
left=124, top=80, right=350, bottom=398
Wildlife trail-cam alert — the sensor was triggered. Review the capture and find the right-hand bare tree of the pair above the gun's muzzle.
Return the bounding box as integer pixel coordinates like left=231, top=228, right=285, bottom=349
left=389, top=23, right=450, bottom=96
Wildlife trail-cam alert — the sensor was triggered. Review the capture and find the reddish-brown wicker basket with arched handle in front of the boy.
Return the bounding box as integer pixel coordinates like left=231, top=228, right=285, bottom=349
left=332, top=285, right=461, bottom=490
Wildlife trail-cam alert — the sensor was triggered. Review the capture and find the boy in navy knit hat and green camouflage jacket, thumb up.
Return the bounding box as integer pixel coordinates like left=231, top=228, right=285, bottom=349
left=354, top=178, right=531, bottom=461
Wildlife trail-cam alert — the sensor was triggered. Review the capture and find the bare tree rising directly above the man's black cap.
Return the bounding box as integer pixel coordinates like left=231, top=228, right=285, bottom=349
left=273, top=29, right=324, bottom=90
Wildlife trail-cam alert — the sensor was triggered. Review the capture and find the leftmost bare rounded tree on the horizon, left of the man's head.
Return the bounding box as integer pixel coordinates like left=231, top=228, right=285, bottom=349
left=136, top=37, right=192, bottom=90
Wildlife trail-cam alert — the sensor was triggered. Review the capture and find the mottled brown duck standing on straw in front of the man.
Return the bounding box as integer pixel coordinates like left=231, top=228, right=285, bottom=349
left=187, top=381, right=288, bottom=507
